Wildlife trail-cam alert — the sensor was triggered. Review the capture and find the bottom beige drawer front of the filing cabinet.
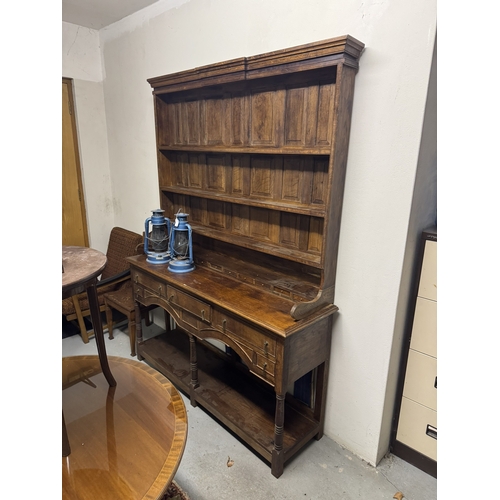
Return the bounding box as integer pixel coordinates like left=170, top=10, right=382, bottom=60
left=396, top=397, right=437, bottom=461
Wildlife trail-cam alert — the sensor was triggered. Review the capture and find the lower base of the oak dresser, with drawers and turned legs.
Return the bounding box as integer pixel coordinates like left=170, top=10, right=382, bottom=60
left=129, top=256, right=338, bottom=477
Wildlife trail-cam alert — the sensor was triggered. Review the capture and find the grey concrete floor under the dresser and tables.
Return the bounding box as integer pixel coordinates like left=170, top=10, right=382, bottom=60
left=62, top=323, right=437, bottom=500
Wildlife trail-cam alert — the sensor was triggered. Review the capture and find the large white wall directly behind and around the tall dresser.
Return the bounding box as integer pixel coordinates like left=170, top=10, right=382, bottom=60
left=63, top=0, right=436, bottom=464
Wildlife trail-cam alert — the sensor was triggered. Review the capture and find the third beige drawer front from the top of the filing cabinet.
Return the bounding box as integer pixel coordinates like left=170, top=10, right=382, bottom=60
left=403, top=349, right=437, bottom=410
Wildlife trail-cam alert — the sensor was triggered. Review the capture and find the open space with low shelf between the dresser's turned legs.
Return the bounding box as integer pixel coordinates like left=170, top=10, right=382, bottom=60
left=139, top=330, right=319, bottom=462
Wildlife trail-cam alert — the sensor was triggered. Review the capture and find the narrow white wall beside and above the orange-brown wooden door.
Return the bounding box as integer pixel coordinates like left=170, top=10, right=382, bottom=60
left=62, top=23, right=114, bottom=252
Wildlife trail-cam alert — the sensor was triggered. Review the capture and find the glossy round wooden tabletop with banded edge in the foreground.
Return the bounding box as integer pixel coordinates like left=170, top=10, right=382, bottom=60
left=62, top=356, right=187, bottom=500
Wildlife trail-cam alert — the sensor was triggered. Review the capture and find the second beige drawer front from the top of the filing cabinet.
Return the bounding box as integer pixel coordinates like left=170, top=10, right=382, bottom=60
left=410, top=297, right=437, bottom=358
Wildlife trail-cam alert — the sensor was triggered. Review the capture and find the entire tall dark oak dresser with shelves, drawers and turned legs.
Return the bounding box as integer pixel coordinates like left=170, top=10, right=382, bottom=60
left=129, top=35, right=364, bottom=477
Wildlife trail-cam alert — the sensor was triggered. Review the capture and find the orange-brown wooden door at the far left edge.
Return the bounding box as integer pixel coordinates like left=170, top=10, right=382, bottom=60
left=62, top=78, right=89, bottom=247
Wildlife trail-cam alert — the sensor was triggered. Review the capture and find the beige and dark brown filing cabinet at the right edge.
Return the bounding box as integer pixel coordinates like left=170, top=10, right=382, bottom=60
left=392, top=230, right=437, bottom=477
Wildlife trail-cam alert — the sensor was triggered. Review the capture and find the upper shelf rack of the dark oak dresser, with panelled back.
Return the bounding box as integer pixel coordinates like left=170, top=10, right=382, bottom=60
left=148, top=35, right=364, bottom=320
